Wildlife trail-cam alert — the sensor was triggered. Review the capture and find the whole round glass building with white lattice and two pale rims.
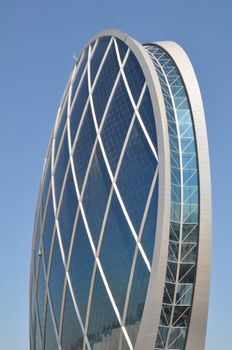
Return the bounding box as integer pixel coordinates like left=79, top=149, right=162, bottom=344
left=30, top=30, right=211, bottom=350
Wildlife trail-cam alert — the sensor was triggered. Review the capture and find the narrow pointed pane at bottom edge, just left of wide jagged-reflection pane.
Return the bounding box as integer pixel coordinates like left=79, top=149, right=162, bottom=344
left=61, top=285, right=83, bottom=350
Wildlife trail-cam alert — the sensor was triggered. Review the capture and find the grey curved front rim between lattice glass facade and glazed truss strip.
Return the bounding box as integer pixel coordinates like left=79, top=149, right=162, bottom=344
left=86, top=29, right=170, bottom=350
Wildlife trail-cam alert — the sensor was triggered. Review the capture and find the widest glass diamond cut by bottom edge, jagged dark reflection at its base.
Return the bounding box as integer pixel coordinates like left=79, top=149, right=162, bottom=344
left=87, top=270, right=120, bottom=350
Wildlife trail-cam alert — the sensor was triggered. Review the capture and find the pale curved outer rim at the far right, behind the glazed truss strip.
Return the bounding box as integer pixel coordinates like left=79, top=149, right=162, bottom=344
left=154, top=41, right=212, bottom=350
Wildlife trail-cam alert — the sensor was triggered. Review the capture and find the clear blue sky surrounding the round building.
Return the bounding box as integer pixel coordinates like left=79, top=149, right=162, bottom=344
left=0, top=0, right=232, bottom=350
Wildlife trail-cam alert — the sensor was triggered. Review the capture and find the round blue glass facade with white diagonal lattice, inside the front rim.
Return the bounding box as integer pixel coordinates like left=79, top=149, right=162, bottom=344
left=31, top=36, right=159, bottom=350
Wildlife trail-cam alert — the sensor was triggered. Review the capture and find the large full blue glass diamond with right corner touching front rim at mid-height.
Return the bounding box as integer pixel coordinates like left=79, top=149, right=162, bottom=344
left=117, top=119, right=157, bottom=231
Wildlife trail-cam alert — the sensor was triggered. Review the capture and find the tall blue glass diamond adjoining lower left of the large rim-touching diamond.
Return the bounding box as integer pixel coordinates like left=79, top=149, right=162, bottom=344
left=100, top=193, right=136, bottom=317
